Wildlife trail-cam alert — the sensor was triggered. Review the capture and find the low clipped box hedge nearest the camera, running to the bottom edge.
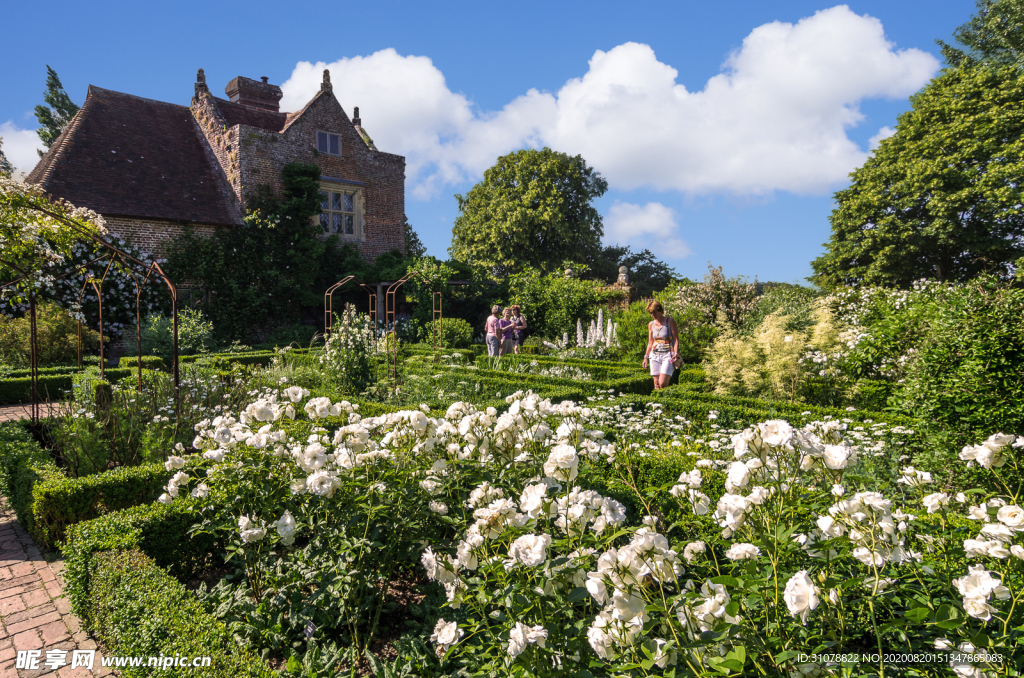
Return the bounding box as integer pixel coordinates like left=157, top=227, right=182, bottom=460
left=63, top=500, right=276, bottom=678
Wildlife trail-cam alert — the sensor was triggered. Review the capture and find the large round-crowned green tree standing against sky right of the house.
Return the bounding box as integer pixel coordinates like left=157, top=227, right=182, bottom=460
left=449, top=149, right=608, bottom=277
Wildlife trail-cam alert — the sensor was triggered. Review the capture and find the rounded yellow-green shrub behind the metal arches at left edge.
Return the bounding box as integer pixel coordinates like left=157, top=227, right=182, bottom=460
left=0, top=303, right=99, bottom=367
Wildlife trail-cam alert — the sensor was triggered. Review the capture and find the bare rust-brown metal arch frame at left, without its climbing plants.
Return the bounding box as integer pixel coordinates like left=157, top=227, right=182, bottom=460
left=0, top=207, right=181, bottom=424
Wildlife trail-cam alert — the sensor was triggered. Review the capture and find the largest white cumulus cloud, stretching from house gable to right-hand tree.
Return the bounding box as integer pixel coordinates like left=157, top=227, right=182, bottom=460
left=282, top=5, right=939, bottom=198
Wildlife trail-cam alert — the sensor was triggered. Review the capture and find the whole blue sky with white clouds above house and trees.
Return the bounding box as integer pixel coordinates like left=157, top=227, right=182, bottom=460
left=0, top=0, right=974, bottom=282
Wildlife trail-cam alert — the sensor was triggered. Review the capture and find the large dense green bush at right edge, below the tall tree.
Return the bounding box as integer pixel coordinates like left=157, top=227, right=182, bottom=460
left=899, top=278, right=1024, bottom=443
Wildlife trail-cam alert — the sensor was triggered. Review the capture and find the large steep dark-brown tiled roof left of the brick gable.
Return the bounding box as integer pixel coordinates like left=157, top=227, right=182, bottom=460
left=27, top=85, right=240, bottom=224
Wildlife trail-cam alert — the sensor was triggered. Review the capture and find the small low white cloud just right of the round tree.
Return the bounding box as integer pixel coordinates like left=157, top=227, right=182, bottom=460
left=604, top=201, right=691, bottom=259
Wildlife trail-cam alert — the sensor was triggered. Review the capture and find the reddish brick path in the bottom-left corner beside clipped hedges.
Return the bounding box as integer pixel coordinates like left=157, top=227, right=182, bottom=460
left=0, top=498, right=117, bottom=678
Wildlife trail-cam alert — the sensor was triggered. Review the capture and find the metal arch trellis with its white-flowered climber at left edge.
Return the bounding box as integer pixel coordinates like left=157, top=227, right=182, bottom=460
left=0, top=181, right=180, bottom=422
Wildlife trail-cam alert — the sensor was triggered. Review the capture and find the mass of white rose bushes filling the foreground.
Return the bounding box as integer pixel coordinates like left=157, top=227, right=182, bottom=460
left=161, top=378, right=1024, bottom=677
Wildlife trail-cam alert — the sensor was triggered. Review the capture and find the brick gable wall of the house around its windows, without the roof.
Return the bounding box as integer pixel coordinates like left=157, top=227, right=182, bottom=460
left=234, top=84, right=406, bottom=261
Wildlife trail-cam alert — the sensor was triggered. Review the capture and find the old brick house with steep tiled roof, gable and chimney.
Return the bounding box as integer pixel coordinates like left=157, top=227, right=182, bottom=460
left=26, top=69, right=406, bottom=260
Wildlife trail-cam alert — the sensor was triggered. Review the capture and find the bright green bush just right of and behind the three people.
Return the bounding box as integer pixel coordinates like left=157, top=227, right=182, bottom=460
left=503, top=266, right=617, bottom=338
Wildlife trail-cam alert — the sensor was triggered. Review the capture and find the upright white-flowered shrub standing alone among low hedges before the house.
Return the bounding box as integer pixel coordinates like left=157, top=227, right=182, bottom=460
left=319, top=304, right=377, bottom=393
